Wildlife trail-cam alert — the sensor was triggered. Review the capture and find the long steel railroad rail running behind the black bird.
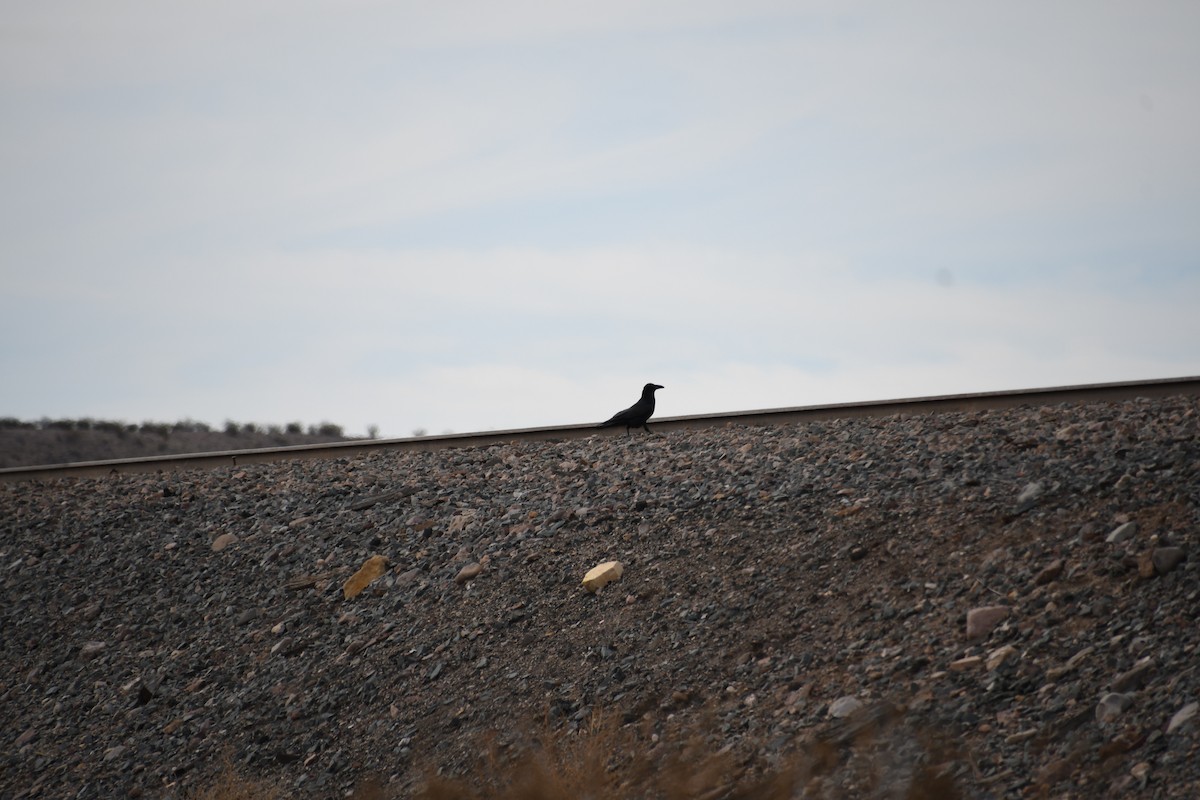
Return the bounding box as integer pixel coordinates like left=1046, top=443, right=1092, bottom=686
left=0, top=377, right=1200, bottom=482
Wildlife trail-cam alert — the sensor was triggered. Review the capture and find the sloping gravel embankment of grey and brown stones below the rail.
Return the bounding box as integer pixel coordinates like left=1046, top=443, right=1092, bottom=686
left=0, top=398, right=1200, bottom=800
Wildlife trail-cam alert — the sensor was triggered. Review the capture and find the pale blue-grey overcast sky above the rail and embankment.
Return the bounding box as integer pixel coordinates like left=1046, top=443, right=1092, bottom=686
left=0, top=0, right=1200, bottom=437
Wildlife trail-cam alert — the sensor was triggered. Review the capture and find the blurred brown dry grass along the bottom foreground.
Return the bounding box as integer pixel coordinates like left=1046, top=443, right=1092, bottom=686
left=197, top=722, right=962, bottom=800
